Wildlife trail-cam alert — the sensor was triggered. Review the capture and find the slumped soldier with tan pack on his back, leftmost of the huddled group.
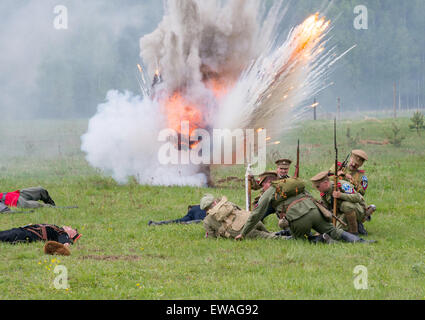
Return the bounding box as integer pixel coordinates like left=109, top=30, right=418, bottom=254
left=201, top=194, right=282, bottom=239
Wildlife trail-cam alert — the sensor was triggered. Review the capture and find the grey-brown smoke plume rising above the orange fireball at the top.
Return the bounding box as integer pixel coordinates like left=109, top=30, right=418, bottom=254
left=140, top=0, right=268, bottom=92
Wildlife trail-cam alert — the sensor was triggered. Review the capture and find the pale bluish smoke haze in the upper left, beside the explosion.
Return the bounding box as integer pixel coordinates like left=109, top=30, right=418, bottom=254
left=0, top=0, right=162, bottom=119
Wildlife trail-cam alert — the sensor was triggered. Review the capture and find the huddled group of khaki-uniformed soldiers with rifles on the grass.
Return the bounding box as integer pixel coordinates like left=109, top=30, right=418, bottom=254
left=200, top=150, right=376, bottom=243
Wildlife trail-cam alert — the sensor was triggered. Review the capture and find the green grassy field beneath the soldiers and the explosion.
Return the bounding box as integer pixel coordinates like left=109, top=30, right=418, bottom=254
left=0, top=119, right=425, bottom=299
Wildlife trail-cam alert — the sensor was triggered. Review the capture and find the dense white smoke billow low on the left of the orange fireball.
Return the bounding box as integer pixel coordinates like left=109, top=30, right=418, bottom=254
left=81, top=91, right=206, bottom=186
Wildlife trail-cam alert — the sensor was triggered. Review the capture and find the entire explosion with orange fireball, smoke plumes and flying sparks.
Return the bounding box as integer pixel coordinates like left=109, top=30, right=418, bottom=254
left=82, top=0, right=335, bottom=186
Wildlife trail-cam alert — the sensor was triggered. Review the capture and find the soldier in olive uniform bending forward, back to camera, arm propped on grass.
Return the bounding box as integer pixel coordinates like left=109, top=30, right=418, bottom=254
left=235, top=178, right=372, bottom=242
